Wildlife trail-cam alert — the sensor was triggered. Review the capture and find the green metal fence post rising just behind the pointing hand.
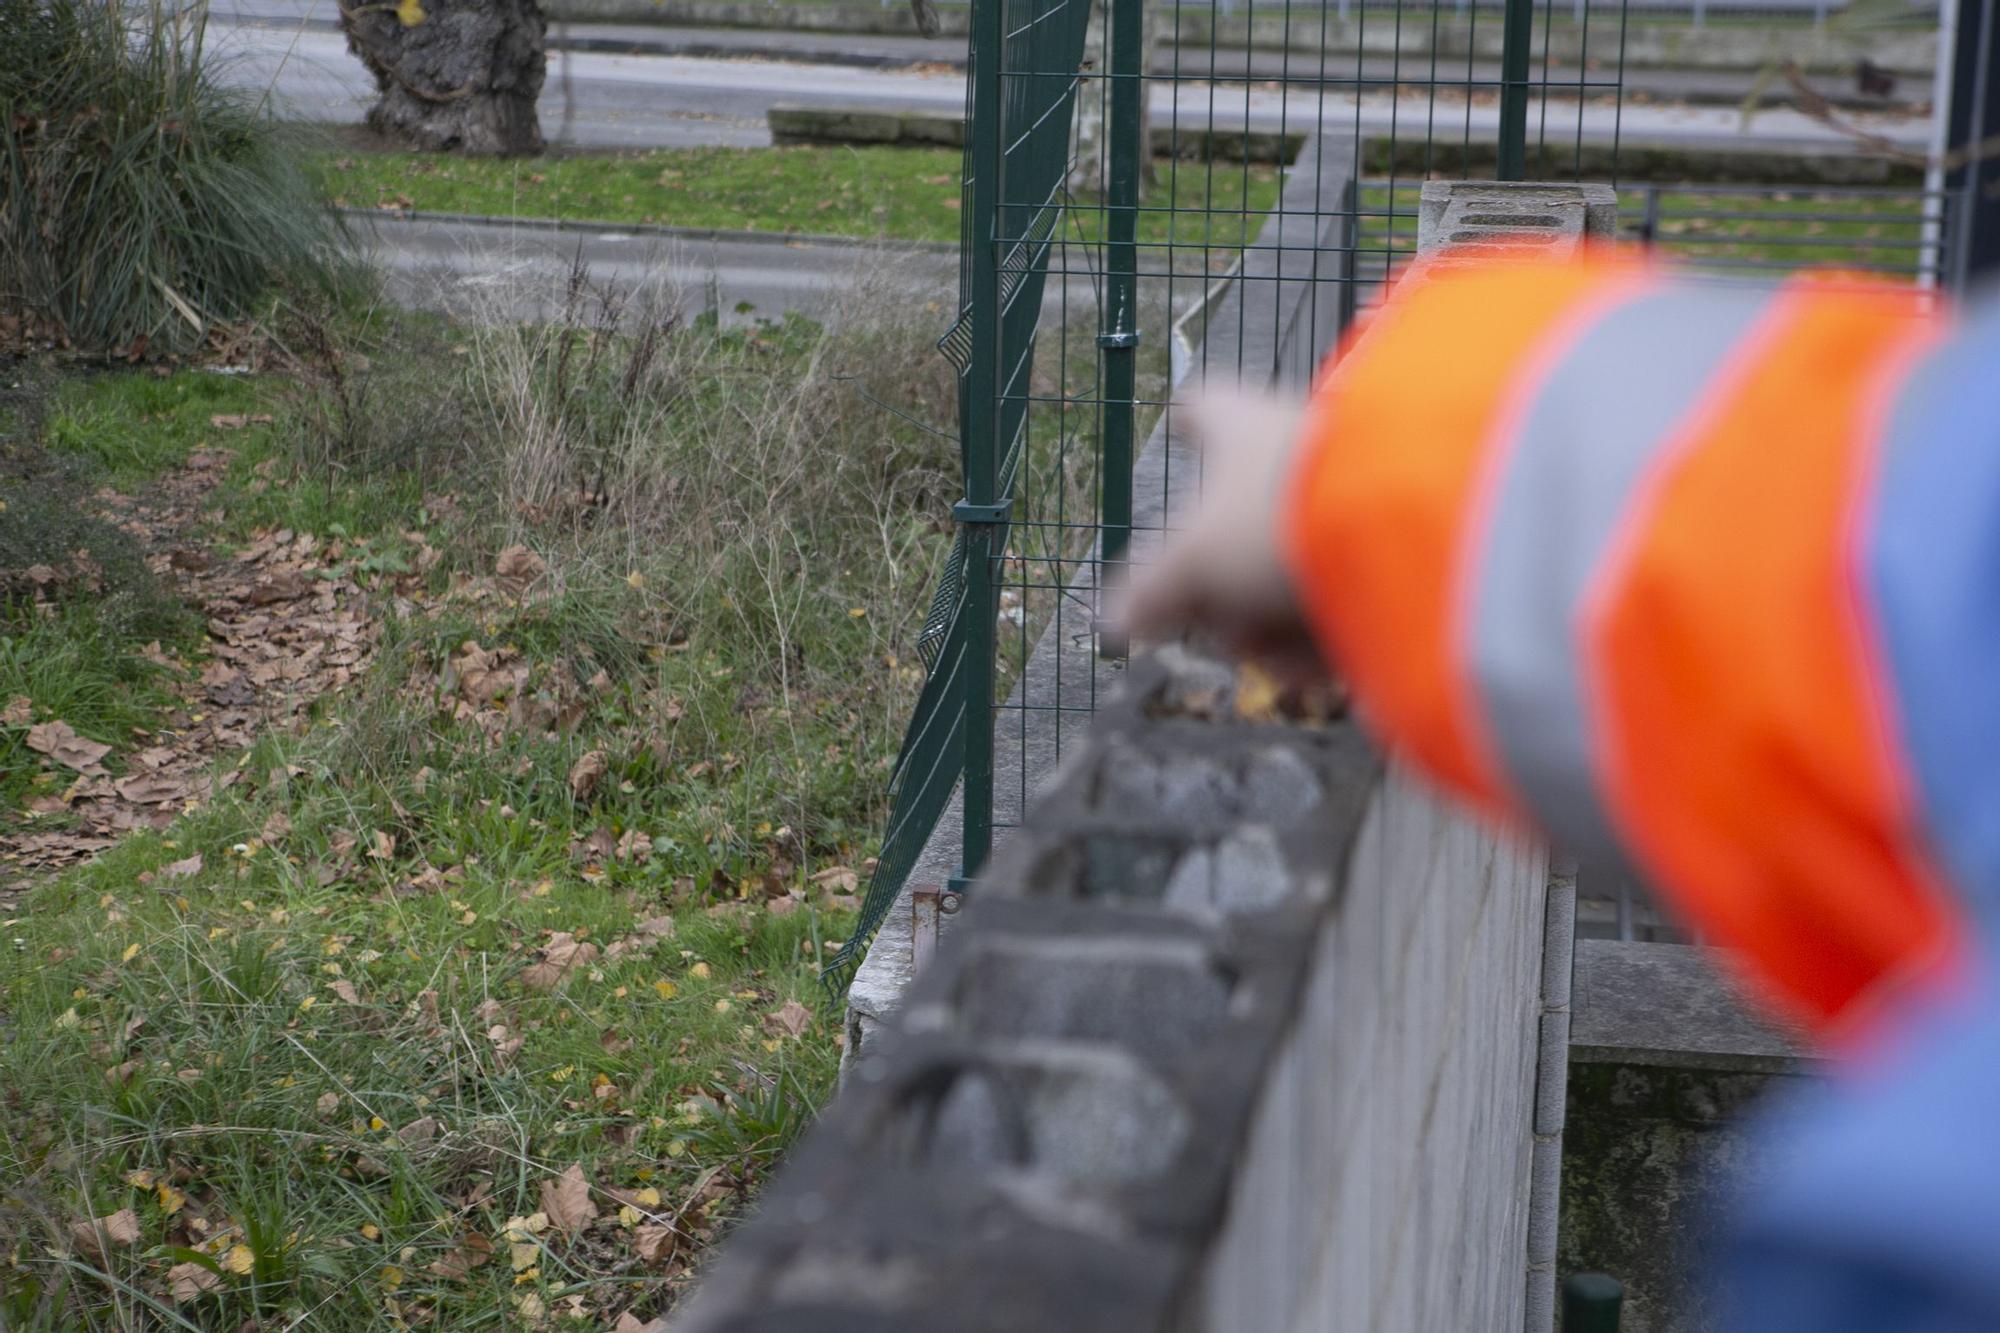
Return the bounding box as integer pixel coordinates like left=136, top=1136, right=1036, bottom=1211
left=1098, top=0, right=1146, bottom=572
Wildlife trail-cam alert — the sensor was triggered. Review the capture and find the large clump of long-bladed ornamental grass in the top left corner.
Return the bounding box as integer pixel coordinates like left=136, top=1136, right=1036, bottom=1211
left=0, top=0, right=340, bottom=360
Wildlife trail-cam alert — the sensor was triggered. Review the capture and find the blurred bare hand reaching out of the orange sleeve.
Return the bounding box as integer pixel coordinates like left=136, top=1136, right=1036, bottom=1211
left=1114, top=390, right=1326, bottom=681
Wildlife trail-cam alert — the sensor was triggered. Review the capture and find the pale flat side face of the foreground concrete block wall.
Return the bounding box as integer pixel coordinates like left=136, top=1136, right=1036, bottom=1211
left=1200, top=773, right=1548, bottom=1331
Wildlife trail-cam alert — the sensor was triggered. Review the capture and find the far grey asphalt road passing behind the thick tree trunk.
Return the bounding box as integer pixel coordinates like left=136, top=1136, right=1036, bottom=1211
left=199, top=0, right=1928, bottom=152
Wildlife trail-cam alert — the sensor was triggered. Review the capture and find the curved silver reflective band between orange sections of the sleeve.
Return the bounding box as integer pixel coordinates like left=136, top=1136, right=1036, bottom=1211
left=1468, top=284, right=1772, bottom=860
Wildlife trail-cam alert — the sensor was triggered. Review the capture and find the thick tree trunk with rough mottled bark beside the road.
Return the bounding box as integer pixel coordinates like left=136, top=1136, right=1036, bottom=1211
left=340, top=0, right=548, bottom=156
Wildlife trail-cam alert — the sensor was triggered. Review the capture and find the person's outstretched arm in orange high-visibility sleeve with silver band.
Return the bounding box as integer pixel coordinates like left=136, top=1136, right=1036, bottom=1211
left=1134, top=256, right=2000, bottom=1041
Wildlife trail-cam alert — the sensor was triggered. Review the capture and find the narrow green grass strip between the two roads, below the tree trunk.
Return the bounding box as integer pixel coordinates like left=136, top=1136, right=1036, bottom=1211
left=318, top=146, right=1278, bottom=244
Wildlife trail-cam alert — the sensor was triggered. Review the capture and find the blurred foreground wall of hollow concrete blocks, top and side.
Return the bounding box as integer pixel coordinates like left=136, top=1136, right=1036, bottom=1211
left=678, top=648, right=1548, bottom=1333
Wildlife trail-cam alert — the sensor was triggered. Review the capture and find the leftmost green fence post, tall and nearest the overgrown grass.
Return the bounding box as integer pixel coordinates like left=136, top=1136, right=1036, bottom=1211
left=954, top=0, right=1006, bottom=881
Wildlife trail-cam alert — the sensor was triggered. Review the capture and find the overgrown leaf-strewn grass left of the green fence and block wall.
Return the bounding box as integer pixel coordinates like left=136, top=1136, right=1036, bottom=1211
left=0, top=280, right=952, bottom=1329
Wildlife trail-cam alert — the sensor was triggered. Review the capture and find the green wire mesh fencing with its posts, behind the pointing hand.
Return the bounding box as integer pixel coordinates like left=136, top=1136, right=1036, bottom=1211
left=836, top=0, right=1656, bottom=971
